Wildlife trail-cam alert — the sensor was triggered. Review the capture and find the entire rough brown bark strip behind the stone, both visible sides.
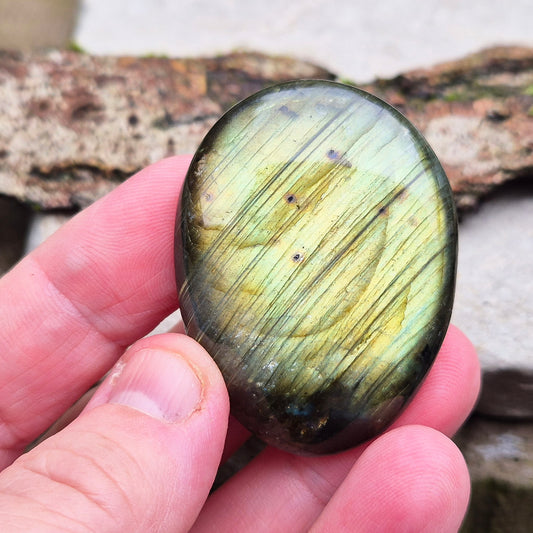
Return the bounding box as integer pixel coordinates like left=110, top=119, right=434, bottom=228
left=0, top=47, right=533, bottom=209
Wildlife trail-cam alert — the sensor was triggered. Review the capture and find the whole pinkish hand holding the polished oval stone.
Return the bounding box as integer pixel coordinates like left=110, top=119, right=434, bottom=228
left=0, top=157, right=479, bottom=533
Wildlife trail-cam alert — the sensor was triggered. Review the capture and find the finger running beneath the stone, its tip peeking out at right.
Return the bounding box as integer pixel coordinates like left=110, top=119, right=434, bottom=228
left=193, top=328, right=479, bottom=533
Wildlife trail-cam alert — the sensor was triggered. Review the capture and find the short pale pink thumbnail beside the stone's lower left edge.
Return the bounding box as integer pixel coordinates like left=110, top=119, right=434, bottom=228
left=108, top=349, right=202, bottom=422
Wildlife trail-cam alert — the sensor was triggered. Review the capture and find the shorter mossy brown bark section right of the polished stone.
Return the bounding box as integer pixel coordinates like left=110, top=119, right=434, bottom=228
left=360, top=47, right=533, bottom=208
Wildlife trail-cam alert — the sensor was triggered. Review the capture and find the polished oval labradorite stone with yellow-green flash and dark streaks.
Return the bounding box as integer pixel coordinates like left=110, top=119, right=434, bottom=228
left=172, top=81, right=457, bottom=454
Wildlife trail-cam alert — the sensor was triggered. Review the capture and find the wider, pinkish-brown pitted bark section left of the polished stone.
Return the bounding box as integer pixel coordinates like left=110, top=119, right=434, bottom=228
left=0, top=51, right=334, bottom=209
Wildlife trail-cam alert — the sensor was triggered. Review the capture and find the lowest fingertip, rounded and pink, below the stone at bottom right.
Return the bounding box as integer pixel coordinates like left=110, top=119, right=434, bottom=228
left=310, top=426, right=470, bottom=533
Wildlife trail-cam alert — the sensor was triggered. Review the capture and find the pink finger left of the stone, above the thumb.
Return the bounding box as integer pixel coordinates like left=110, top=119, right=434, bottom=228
left=0, top=157, right=189, bottom=467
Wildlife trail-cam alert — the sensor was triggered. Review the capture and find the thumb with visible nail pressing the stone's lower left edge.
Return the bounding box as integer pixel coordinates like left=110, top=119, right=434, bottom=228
left=0, top=334, right=229, bottom=533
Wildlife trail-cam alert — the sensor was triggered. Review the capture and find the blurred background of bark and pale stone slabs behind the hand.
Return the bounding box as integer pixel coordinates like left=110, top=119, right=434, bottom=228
left=0, top=0, right=533, bottom=533
